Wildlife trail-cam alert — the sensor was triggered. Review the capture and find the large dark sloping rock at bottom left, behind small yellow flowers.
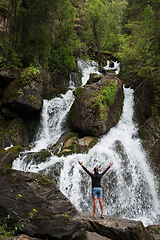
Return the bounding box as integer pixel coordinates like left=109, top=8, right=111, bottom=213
left=0, top=168, right=82, bottom=239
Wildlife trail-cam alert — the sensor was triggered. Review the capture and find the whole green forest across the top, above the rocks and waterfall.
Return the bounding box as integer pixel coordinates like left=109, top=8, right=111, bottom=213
left=0, top=0, right=160, bottom=116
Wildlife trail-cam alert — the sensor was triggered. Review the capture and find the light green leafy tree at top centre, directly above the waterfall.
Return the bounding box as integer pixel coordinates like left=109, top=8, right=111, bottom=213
left=83, top=0, right=127, bottom=56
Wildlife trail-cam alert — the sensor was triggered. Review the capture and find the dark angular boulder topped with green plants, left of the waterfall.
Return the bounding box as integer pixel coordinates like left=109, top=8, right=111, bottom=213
left=2, top=68, right=43, bottom=118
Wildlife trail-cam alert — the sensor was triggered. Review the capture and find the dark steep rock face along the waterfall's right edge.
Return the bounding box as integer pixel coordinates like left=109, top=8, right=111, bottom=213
left=128, top=73, right=160, bottom=175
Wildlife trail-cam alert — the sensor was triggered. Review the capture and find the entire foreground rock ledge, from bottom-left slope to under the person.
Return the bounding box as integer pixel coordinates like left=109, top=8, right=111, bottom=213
left=0, top=167, right=155, bottom=240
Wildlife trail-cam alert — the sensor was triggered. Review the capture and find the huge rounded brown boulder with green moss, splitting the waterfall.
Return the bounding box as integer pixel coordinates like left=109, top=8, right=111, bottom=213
left=70, top=73, right=123, bottom=137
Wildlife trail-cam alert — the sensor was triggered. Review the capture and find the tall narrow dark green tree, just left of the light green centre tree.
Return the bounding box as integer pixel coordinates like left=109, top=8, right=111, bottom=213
left=49, top=0, right=80, bottom=75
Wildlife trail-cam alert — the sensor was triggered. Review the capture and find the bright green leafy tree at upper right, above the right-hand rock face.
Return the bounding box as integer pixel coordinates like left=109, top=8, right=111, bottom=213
left=118, top=5, right=157, bottom=77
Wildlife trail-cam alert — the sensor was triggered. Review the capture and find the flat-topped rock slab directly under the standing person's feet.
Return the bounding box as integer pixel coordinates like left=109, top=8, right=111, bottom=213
left=81, top=213, right=154, bottom=240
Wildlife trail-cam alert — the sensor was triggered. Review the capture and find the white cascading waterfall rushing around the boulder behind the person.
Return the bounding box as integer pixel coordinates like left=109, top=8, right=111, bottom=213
left=13, top=59, right=160, bottom=225
